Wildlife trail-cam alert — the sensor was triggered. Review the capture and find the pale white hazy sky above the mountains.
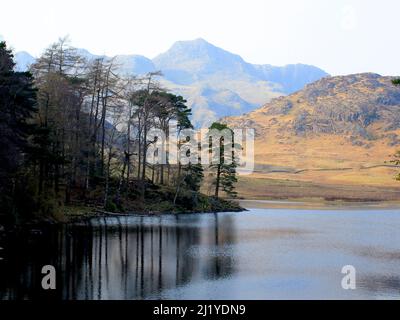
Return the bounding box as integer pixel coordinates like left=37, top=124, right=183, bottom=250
left=0, top=0, right=400, bottom=75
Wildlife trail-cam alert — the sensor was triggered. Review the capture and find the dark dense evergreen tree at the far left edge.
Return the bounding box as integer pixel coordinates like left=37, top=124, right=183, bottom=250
left=0, top=42, right=36, bottom=213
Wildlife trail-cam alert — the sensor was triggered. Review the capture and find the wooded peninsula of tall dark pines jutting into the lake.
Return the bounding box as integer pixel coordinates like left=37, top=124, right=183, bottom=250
left=0, top=39, right=242, bottom=224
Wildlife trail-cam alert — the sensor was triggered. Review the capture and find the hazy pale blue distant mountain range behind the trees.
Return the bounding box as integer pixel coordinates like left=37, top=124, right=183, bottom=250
left=16, top=38, right=328, bottom=126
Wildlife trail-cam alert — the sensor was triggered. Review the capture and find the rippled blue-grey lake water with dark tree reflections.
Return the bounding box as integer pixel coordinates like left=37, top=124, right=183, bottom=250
left=0, top=205, right=400, bottom=299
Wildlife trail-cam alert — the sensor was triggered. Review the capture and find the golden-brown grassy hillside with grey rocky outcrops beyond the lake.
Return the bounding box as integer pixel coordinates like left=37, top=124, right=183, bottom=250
left=223, top=73, right=400, bottom=200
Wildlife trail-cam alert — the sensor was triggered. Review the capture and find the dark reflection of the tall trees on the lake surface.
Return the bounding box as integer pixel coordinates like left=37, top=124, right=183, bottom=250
left=0, top=214, right=235, bottom=300
